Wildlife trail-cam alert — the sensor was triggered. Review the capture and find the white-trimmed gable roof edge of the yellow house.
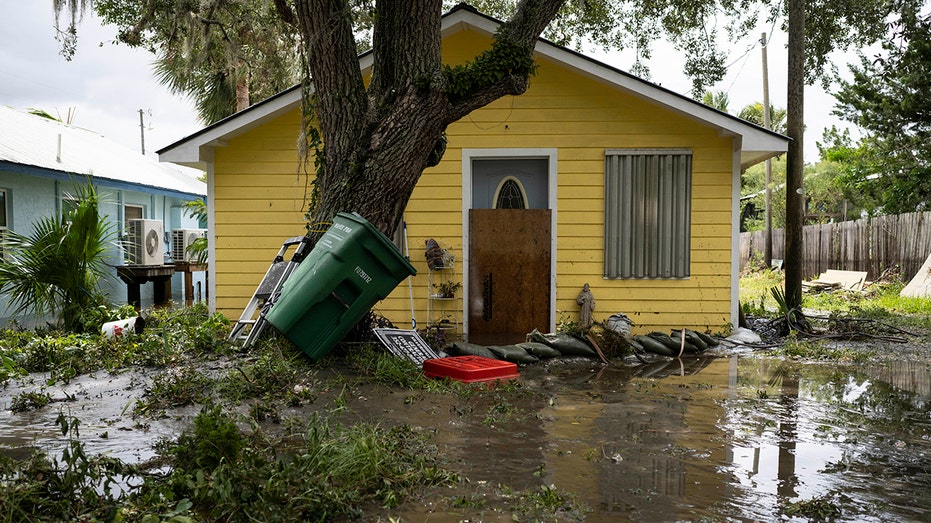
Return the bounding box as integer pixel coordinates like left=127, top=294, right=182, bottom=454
left=157, top=4, right=789, bottom=169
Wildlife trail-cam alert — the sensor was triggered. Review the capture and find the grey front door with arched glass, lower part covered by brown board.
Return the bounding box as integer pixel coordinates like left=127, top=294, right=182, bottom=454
left=468, top=158, right=552, bottom=345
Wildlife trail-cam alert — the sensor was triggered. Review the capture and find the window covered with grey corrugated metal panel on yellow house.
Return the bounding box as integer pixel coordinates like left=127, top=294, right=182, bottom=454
left=604, top=149, right=692, bottom=278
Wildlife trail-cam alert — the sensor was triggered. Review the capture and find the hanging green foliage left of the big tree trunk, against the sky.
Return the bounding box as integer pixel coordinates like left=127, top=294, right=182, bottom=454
left=53, top=0, right=300, bottom=124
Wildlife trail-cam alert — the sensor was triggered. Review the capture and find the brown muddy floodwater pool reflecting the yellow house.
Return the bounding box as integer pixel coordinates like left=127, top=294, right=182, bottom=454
left=384, top=356, right=931, bottom=522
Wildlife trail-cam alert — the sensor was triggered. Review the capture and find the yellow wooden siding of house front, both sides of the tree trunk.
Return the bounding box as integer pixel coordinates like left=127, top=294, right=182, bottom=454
left=214, top=25, right=732, bottom=331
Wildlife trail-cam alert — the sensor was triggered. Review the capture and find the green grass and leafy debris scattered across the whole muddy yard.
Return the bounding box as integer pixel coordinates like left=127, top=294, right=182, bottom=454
left=7, top=284, right=931, bottom=522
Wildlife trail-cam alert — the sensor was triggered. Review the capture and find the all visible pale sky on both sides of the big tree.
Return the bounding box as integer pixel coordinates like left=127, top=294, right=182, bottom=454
left=0, top=0, right=856, bottom=162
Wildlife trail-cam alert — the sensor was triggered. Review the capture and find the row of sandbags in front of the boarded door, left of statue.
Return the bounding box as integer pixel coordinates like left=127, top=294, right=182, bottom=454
left=447, top=329, right=598, bottom=363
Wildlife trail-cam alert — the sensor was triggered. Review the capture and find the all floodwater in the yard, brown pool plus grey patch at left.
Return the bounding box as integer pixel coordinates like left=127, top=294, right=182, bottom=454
left=0, top=354, right=931, bottom=522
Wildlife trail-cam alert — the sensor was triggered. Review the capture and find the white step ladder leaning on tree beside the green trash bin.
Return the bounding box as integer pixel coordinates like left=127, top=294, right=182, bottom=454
left=229, top=236, right=308, bottom=349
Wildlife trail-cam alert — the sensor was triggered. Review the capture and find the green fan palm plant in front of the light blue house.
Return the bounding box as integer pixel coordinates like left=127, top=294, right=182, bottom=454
left=0, top=180, right=116, bottom=331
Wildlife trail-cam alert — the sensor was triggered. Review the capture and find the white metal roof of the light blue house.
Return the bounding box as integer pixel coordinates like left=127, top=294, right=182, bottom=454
left=0, top=106, right=207, bottom=198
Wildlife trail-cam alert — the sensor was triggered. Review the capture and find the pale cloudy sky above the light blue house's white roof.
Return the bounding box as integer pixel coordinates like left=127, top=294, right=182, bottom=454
left=0, top=0, right=203, bottom=158
